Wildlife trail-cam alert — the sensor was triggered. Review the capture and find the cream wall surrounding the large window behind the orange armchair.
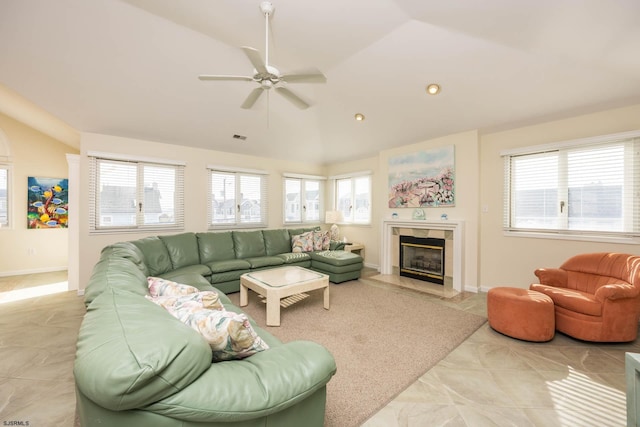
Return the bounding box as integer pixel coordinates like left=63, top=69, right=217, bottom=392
left=479, top=105, right=640, bottom=289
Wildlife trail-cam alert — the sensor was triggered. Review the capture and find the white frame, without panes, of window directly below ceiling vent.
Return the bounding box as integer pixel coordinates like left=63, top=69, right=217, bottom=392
left=207, top=165, right=269, bottom=230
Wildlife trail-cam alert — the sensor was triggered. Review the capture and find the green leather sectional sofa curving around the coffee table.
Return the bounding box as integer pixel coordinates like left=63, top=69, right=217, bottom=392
left=74, top=230, right=362, bottom=427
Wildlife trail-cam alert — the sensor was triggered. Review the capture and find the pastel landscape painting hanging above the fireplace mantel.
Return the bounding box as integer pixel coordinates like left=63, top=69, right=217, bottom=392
left=389, top=145, right=455, bottom=208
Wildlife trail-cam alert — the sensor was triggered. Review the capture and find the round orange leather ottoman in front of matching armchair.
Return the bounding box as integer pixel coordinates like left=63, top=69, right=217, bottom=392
left=487, top=287, right=556, bottom=342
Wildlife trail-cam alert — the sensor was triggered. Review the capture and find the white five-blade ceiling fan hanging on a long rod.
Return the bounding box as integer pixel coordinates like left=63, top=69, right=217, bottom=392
left=198, top=1, right=327, bottom=109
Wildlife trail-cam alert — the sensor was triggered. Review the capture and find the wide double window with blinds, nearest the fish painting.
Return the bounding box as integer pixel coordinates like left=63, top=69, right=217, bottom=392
left=89, top=155, right=184, bottom=231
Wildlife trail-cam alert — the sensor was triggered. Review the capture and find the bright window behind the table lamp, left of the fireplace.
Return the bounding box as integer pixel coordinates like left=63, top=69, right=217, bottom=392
left=335, top=175, right=371, bottom=224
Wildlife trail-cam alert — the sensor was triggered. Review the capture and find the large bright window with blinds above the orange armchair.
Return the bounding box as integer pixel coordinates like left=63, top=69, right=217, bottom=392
left=503, top=132, right=640, bottom=237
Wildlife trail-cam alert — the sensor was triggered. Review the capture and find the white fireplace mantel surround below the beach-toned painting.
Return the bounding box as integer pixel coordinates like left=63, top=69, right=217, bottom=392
left=380, top=219, right=464, bottom=292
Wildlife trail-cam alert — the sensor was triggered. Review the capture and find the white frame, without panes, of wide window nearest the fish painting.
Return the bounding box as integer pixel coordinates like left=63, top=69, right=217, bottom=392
left=87, top=152, right=185, bottom=234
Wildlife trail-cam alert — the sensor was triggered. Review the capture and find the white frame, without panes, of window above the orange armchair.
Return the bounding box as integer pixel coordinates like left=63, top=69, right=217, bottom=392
left=500, top=130, right=640, bottom=244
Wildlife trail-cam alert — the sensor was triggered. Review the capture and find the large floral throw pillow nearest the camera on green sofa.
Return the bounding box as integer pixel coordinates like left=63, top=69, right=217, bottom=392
left=170, top=307, right=269, bottom=362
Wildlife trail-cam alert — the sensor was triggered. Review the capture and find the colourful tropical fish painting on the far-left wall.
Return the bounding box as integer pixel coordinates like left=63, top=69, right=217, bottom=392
left=27, top=176, right=69, bottom=229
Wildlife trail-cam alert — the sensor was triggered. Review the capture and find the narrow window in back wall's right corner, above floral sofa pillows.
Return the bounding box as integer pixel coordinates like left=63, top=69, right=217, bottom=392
left=283, top=174, right=324, bottom=224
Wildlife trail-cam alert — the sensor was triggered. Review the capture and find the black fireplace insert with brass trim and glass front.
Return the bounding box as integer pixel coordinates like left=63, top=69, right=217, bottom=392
left=400, top=236, right=445, bottom=285
